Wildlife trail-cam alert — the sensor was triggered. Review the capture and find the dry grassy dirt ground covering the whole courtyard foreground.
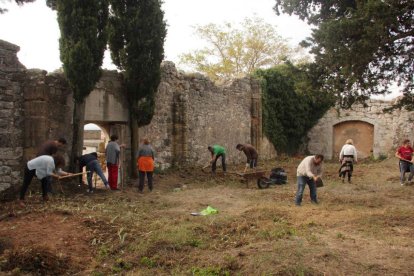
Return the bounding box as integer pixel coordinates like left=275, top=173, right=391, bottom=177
left=0, top=158, right=414, bottom=275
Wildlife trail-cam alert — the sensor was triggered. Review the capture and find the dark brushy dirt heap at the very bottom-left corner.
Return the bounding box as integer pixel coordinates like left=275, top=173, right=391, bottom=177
left=1, top=247, right=74, bottom=275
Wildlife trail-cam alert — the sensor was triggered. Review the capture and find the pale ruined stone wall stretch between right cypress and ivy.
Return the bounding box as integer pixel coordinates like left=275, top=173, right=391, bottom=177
left=140, top=62, right=275, bottom=168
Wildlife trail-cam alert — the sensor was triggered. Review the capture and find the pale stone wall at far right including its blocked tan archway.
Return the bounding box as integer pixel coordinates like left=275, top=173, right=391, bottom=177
left=308, top=100, right=414, bottom=158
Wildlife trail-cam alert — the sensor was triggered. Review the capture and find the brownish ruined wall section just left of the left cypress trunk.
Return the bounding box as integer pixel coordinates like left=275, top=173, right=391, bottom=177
left=21, top=69, right=73, bottom=164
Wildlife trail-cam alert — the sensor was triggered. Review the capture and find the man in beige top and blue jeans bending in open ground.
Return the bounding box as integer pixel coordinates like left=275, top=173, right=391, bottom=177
left=295, top=154, right=323, bottom=206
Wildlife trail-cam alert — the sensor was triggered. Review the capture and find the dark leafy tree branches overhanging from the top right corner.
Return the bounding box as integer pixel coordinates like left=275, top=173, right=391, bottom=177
left=274, top=0, right=414, bottom=109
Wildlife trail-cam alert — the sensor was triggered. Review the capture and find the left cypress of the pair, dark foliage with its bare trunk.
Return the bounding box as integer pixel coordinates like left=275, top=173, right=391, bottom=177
left=48, top=0, right=108, bottom=169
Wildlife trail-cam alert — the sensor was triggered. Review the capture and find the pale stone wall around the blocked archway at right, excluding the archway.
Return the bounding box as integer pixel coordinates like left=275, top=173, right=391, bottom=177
left=308, top=100, right=414, bottom=158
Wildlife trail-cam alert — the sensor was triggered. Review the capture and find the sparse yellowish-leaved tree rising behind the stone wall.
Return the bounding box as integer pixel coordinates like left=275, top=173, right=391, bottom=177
left=181, top=17, right=306, bottom=81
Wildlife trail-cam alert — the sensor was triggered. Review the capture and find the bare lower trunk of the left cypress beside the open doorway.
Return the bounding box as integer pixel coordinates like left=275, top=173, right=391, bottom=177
left=69, top=100, right=85, bottom=172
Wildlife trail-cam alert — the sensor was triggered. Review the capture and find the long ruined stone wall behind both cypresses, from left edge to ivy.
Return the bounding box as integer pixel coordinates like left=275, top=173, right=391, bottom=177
left=0, top=40, right=275, bottom=191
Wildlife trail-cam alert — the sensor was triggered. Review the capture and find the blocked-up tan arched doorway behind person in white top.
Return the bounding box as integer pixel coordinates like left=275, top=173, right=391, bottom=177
left=333, top=121, right=374, bottom=158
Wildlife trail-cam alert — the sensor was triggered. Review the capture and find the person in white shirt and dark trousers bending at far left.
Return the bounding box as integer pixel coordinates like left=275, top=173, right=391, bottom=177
left=20, top=155, right=69, bottom=205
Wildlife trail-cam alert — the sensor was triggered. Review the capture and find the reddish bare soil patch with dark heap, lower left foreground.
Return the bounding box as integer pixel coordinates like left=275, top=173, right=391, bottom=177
left=0, top=210, right=94, bottom=275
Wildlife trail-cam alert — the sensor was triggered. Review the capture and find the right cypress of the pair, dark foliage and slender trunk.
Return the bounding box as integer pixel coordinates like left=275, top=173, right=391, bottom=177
left=109, top=0, right=166, bottom=177
